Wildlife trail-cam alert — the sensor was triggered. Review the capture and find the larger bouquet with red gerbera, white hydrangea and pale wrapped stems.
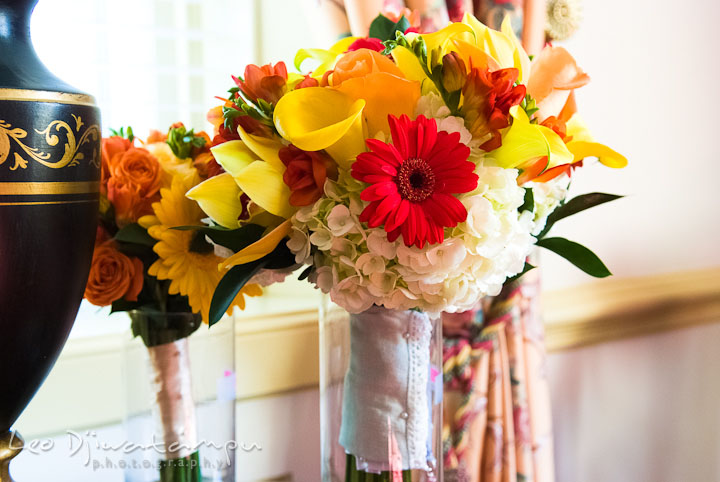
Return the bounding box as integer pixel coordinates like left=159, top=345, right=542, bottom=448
left=188, top=15, right=627, bottom=480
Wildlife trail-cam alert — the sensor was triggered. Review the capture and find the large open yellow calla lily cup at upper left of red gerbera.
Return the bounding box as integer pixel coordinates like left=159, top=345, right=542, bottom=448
left=273, top=87, right=365, bottom=168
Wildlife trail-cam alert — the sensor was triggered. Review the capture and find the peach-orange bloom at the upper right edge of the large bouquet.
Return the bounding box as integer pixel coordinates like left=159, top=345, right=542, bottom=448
left=527, top=47, right=590, bottom=121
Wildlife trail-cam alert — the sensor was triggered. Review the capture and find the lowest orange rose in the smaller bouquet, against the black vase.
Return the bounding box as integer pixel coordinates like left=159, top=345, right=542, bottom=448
left=85, top=241, right=143, bottom=306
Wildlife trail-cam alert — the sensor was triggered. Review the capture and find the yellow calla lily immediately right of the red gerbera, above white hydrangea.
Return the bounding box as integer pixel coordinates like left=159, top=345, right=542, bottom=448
left=488, top=106, right=573, bottom=169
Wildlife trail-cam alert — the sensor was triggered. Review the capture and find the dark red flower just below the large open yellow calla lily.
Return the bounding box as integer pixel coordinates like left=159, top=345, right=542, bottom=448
left=278, top=144, right=337, bottom=206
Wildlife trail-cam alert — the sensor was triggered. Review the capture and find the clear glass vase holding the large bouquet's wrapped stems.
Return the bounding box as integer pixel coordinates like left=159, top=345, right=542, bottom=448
left=320, top=297, right=442, bottom=482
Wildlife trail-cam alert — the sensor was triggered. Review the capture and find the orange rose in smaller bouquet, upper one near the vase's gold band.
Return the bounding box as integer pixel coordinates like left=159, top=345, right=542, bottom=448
left=107, top=147, right=162, bottom=227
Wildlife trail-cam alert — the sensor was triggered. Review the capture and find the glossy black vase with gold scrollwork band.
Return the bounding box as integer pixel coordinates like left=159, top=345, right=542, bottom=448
left=0, top=0, right=101, bottom=460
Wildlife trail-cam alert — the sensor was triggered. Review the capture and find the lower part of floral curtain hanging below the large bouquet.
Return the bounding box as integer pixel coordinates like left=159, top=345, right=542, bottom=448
left=443, top=270, right=554, bottom=482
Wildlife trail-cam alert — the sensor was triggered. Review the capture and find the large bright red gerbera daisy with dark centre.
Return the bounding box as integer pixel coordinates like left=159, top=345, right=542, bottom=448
left=352, top=115, right=478, bottom=248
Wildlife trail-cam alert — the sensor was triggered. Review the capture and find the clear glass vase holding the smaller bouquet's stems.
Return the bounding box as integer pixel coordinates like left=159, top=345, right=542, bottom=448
left=123, top=311, right=236, bottom=482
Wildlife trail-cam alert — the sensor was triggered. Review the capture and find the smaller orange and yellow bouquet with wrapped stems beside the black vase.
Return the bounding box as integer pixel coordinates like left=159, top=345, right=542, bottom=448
left=85, top=124, right=261, bottom=481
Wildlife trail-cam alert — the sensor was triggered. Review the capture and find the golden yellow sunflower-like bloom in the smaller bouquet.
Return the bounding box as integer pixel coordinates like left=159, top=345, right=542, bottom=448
left=138, top=168, right=262, bottom=323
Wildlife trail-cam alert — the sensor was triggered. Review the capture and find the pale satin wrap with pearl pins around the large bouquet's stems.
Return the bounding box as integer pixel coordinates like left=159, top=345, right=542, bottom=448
left=340, top=307, right=432, bottom=472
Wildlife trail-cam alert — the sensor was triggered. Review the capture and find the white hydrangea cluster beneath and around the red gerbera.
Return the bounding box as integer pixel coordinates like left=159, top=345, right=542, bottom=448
left=288, top=94, right=552, bottom=314
